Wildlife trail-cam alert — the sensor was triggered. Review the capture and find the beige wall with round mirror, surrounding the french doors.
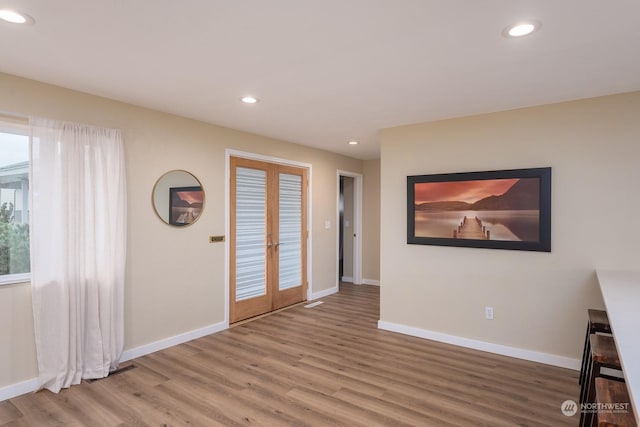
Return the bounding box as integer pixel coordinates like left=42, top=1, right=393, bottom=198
left=0, top=74, right=370, bottom=387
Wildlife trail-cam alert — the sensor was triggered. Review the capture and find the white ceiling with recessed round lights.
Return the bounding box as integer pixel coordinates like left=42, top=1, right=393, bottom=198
left=0, top=0, right=640, bottom=159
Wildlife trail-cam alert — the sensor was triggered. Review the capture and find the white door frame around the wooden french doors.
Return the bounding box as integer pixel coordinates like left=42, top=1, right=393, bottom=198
left=224, top=148, right=313, bottom=328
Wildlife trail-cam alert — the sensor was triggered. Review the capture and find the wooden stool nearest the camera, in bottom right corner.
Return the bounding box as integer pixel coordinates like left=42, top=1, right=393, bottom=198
left=594, top=378, right=637, bottom=427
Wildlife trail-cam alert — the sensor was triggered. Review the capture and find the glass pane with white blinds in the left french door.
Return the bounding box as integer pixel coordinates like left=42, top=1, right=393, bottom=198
left=236, top=167, right=267, bottom=301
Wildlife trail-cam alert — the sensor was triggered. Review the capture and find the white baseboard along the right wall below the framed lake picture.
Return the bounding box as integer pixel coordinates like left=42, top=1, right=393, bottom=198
left=378, top=320, right=580, bottom=371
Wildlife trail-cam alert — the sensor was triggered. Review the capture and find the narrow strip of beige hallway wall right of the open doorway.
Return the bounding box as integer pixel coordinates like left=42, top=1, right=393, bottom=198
left=362, top=159, right=380, bottom=283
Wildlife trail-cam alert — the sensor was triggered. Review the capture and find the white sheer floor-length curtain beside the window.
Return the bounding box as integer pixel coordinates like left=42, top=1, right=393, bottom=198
left=30, top=118, right=127, bottom=393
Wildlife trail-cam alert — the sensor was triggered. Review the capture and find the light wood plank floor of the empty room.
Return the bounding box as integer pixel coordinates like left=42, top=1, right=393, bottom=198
left=0, top=284, right=578, bottom=427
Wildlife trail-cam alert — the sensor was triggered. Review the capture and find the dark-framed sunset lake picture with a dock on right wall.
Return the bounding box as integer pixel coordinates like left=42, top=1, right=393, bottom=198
left=407, top=167, right=551, bottom=252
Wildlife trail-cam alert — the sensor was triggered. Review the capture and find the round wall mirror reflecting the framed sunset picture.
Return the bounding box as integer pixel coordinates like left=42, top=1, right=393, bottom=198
left=152, top=170, right=204, bottom=227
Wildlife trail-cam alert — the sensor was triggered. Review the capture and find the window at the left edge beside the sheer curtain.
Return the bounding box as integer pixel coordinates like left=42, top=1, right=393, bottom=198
left=0, top=122, right=31, bottom=285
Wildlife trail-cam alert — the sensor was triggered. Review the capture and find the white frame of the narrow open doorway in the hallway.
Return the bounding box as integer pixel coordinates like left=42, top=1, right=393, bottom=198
left=335, top=170, right=362, bottom=286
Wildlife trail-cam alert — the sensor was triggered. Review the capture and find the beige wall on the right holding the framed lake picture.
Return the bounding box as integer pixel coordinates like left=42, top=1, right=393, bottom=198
left=380, top=92, right=640, bottom=358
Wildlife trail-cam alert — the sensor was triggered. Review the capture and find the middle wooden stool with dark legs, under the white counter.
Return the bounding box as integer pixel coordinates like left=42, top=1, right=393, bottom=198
left=580, top=334, right=624, bottom=426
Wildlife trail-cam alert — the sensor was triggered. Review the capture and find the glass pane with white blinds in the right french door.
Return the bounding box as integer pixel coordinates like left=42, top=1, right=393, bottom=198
left=278, top=173, right=302, bottom=291
